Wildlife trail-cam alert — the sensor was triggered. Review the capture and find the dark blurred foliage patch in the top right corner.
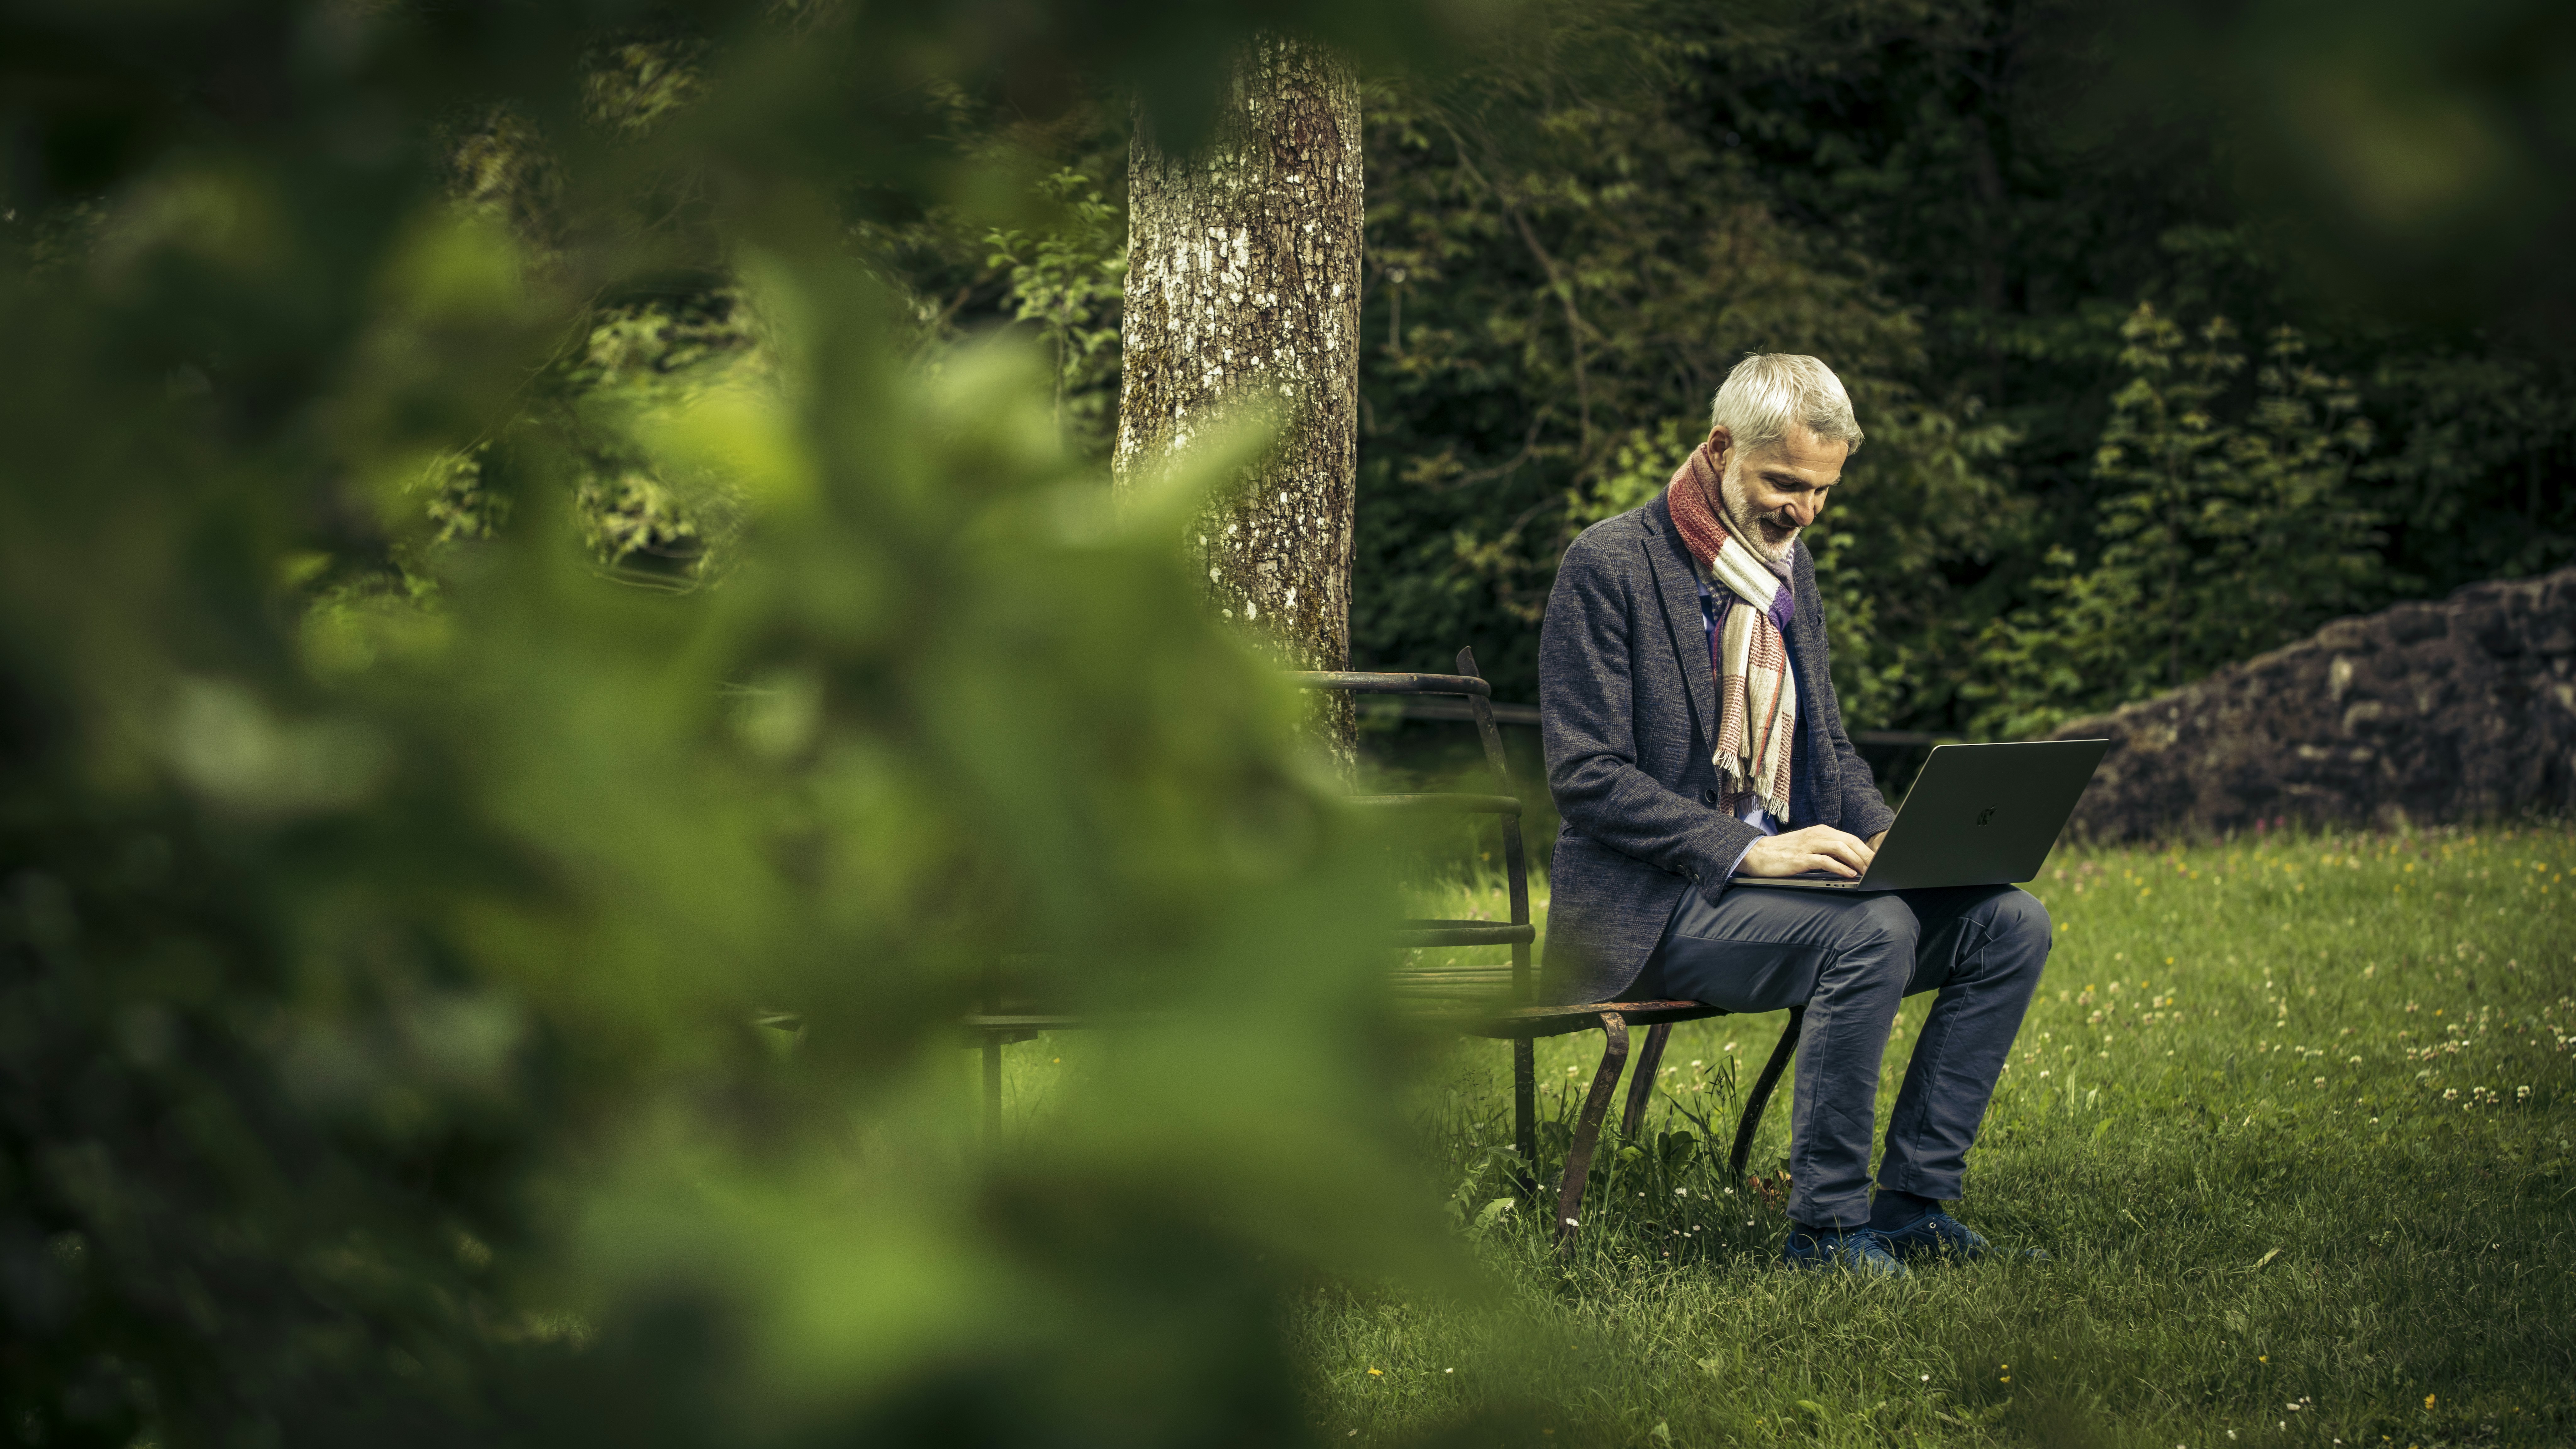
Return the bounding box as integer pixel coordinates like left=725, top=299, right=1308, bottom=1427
left=2097, top=0, right=2576, bottom=343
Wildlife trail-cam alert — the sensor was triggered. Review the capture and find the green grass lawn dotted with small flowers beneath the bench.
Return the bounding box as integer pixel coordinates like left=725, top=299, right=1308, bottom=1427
left=1291, top=828, right=2576, bottom=1449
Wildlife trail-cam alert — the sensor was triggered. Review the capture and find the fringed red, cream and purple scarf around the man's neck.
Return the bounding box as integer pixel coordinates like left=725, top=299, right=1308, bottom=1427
left=1664, top=443, right=1798, bottom=825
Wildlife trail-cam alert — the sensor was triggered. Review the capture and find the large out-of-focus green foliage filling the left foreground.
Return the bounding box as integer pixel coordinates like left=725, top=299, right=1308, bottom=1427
left=0, top=3, right=1494, bottom=1449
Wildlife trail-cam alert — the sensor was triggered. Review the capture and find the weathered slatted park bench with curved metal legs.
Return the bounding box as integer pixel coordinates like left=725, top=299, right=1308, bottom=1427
left=966, top=650, right=1803, bottom=1243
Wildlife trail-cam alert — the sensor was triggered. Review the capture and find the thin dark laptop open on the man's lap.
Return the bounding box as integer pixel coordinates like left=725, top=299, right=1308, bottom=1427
left=1726, top=740, right=2110, bottom=890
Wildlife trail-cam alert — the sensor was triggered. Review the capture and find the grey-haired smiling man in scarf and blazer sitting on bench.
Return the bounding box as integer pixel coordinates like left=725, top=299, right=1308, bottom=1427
left=1538, top=353, right=2051, bottom=1276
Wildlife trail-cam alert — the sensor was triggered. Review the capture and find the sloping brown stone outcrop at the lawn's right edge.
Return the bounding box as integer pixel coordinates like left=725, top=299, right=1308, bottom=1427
left=2056, top=570, right=2576, bottom=841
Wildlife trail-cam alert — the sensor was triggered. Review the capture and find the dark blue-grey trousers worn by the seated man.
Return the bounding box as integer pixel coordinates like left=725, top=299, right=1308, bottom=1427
left=1628, top=884, right=2051, bottom=1227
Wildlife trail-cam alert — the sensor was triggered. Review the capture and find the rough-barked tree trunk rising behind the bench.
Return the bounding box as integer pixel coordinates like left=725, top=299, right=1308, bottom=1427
left=1113, top=34, right=1360, bottom=774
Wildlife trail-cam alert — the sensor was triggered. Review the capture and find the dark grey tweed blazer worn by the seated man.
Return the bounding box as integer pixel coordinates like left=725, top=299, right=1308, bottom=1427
left=1538, top=495, right=1896, bottom=1003
